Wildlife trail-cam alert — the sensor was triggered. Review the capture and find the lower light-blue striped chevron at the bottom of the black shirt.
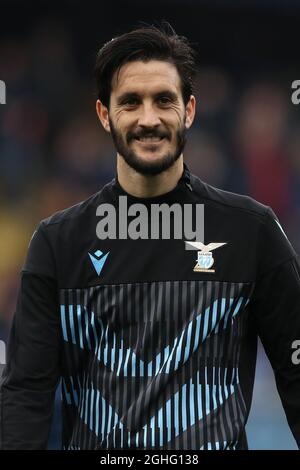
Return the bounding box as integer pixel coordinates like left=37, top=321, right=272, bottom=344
left=63, top=369, right=239, bottom=450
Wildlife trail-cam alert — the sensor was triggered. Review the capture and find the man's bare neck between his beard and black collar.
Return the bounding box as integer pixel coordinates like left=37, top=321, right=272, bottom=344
left=117, top=154, right=183, bottom=198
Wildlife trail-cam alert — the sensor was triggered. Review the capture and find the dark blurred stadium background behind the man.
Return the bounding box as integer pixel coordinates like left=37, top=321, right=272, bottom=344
left=0, top=0, right=300, bottom=449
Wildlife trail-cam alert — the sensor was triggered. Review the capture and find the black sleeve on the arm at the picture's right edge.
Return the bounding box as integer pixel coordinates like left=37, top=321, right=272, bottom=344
left=252, top=209, right=300, bottom=448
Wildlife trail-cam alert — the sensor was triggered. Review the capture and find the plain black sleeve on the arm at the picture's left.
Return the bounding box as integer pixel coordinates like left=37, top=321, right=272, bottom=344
left=0, top=225, right=61, bottom=450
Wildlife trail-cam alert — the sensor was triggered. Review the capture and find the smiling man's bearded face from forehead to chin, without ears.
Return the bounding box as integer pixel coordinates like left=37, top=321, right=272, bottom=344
left=98, top=60, right=195, bottom=175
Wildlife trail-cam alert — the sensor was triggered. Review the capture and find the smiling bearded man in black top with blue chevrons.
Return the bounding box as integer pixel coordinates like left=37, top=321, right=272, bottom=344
left=1, top=26, right=300, bottom=450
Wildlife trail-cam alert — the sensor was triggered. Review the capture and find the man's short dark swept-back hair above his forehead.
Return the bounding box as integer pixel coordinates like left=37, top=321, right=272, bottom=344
left=95, top=22, right=197, bottom=108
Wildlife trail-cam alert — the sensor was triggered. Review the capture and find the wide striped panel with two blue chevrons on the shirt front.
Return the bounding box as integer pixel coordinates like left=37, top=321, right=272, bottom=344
left=60, top=281, right=252, bottom=450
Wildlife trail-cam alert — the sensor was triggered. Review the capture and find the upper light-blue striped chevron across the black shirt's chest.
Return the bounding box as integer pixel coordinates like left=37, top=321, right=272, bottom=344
left=60, top=297, right=249, bottom=377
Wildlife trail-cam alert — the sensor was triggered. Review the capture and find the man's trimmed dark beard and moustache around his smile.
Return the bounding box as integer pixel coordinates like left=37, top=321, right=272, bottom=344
left=109, top=118, right=187, bottom=176
